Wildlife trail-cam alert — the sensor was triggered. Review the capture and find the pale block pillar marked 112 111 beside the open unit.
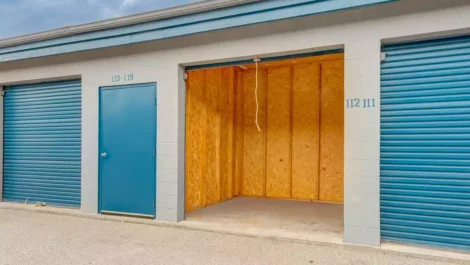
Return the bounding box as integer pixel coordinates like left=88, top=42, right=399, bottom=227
left=344, top=40, right=380, bottom=246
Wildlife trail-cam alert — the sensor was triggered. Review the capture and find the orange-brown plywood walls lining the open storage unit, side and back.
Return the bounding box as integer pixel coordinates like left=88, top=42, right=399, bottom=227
left=186, top=54, right=344, bottom=212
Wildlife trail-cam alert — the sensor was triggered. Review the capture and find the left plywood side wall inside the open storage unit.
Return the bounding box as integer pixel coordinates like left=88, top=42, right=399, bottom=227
left=186, top=68, right=238, bottom=212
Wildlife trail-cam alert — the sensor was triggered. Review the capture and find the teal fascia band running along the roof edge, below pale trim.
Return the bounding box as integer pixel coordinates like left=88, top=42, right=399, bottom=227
left=0, top=0, right=397, bottom=62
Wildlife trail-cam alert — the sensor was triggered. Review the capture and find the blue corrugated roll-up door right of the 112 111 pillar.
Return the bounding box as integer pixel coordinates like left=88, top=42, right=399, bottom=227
left=380, top=37, right=470, bottom=249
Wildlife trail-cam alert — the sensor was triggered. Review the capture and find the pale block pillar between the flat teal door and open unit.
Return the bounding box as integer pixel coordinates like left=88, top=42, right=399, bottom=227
left=156, top=64, right=185, bottom=222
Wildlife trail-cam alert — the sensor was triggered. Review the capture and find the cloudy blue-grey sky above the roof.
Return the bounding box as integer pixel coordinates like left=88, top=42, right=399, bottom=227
left=0, top=0, right=197, bottom=39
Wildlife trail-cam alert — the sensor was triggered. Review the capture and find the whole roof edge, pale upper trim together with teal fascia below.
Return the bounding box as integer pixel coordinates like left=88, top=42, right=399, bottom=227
left=0, top=0, right=399, bottom=63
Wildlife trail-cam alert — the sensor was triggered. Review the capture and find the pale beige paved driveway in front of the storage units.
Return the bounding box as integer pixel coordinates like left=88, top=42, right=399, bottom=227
left=0, top=209, right=465, bottom=265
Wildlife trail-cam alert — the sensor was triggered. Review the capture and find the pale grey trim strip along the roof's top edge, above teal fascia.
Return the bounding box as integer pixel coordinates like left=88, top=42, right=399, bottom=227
left=0, top=0, right=263, bottom=48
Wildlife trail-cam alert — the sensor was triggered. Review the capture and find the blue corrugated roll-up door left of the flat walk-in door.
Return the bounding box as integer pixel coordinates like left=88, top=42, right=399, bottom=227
left=3, top=81, right=82, bottom=207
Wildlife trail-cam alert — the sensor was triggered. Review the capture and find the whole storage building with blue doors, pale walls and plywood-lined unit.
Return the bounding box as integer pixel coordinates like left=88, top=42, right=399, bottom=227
left=0, top=0, right=470, bottom=250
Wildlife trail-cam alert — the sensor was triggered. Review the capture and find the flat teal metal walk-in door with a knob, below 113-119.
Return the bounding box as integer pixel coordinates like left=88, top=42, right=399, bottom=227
left=99, top=84, right=157, bottom=217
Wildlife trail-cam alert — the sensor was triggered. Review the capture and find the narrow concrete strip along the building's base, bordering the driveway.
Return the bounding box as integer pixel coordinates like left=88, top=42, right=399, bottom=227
left=0, top=202, right=470, bottom=262
